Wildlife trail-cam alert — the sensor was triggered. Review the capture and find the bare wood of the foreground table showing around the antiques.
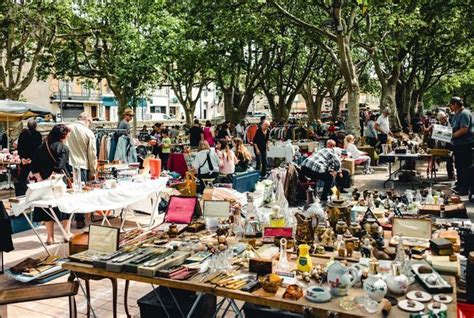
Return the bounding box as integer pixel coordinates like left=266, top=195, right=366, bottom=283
left=63, top=257, right=457, bottom=318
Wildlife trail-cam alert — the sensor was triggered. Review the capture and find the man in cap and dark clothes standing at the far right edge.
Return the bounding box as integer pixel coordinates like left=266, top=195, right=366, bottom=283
left=449, top=97, right=473, bottom=195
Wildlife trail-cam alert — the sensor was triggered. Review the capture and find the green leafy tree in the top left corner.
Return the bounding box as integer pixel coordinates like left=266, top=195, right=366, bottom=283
left=0, top=1, right=70, bottom=99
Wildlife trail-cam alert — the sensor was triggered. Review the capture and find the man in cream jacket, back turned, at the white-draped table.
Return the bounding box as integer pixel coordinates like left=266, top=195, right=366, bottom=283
left=66, top=113, right=97, bottom=229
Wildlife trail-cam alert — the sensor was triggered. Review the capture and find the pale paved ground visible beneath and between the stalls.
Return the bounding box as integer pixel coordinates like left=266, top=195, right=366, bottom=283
left=0, top=166, right=474, bottom=318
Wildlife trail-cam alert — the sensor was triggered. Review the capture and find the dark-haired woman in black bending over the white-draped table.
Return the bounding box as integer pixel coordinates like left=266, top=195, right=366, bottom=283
left=31, top=124, right=71, bottom=245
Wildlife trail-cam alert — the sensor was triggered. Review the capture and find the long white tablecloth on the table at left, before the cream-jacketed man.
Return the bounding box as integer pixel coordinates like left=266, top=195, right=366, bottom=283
left=12, top=177, right=168, bottom=215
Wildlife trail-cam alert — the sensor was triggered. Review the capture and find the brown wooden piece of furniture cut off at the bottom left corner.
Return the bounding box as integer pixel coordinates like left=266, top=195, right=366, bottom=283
left=0, top=282, right=79, bottom=318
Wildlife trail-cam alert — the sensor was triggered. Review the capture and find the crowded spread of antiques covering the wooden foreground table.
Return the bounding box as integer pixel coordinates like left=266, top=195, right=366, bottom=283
left=49, top=181, right=461, bottom=314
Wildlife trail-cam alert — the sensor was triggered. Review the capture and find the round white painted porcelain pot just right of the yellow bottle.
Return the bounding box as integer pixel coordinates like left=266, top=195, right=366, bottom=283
left=328, top=261, right=358, bottom=296
